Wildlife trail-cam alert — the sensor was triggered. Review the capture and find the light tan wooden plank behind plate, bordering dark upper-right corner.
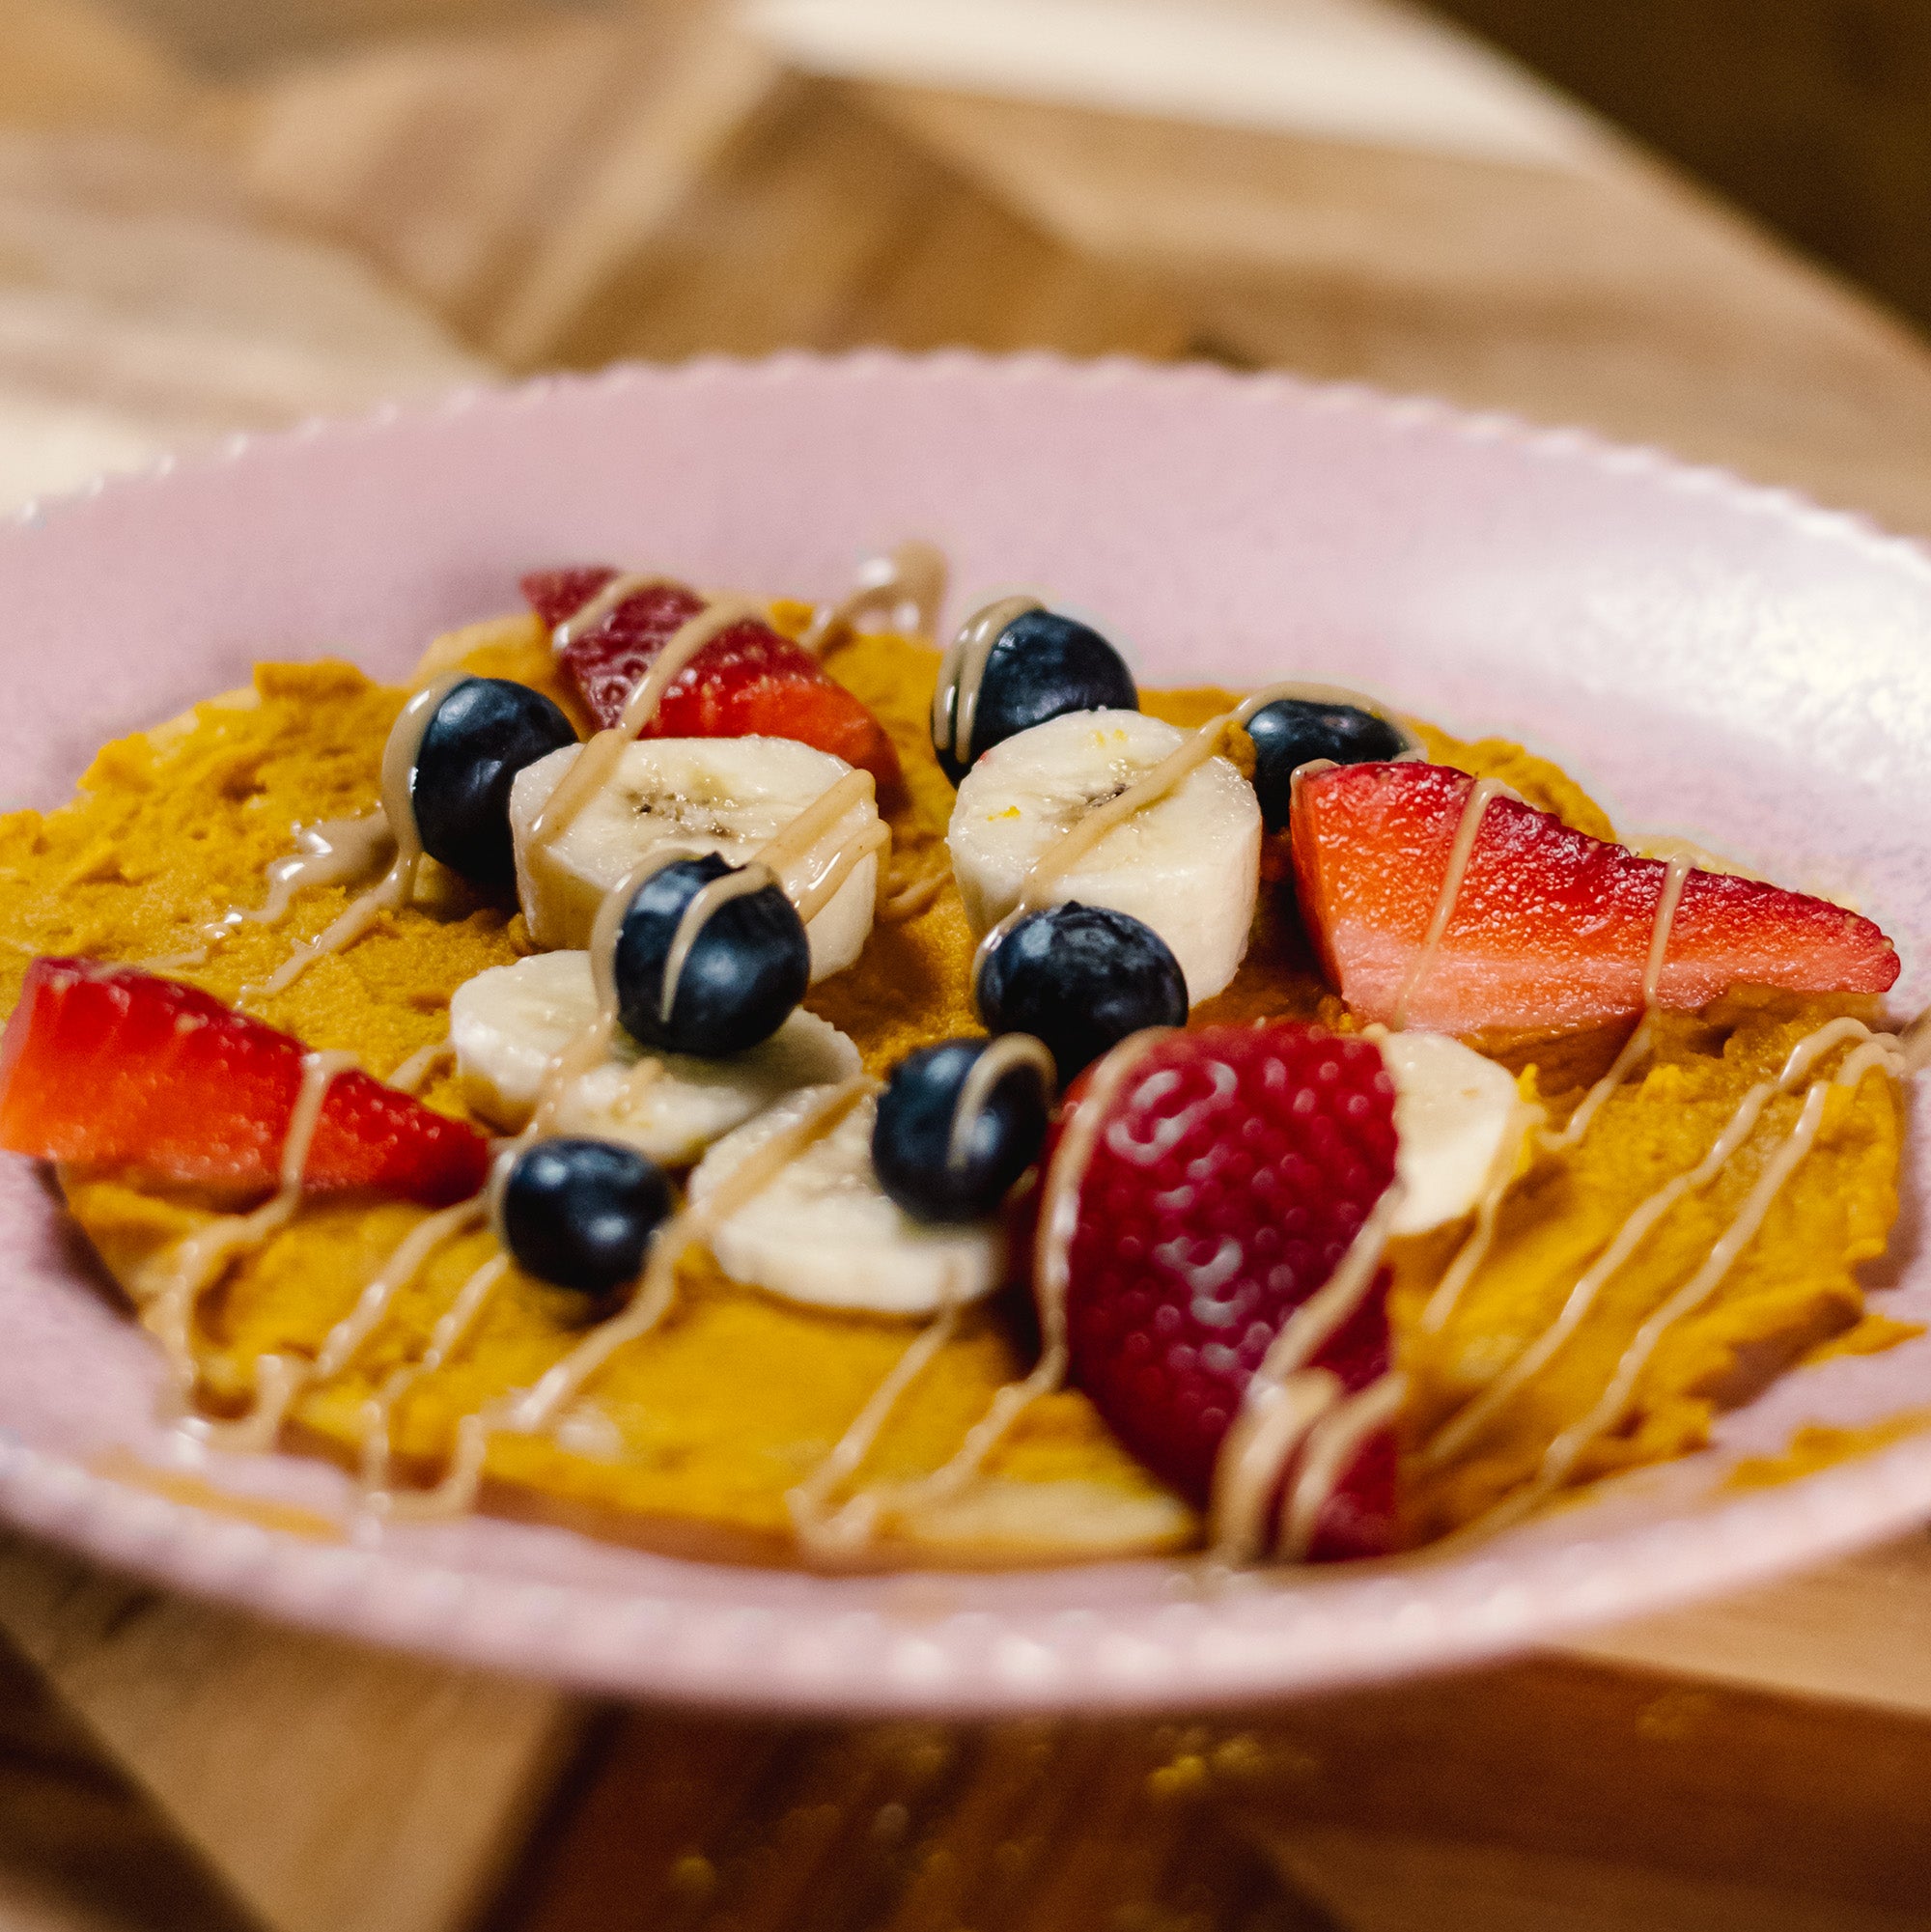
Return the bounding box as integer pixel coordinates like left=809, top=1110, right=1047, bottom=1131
left=867, top=87, right=1931, bottom=531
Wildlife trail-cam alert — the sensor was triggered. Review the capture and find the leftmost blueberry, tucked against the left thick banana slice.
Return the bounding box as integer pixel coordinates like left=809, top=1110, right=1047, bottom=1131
left=409, top=678, right=577, bottom=886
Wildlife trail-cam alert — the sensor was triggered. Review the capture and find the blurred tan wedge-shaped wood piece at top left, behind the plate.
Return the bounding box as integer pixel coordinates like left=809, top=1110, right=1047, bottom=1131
left=234, top=0, right=776, bottom=367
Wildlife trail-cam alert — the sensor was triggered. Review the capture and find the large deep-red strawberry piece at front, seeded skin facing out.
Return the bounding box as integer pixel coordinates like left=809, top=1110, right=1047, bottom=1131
left=1049, top=1022, right=1396, bottom=1555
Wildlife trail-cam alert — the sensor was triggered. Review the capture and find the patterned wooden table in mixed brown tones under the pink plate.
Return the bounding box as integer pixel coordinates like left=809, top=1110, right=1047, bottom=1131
left=11, top=0, right=1931, bottom=1932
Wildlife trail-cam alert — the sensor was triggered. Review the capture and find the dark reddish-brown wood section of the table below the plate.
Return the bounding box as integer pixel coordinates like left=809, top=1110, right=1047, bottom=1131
left=492, top=1662, right=1931, bottom=1932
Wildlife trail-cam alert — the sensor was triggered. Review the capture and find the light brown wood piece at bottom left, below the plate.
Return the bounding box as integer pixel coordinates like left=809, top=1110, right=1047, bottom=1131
left=0, top=1536, right=583, bottom=1932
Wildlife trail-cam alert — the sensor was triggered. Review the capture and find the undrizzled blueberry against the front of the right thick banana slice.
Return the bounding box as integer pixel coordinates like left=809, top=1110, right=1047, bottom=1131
left=975, top=900, right=1188, bottom=1086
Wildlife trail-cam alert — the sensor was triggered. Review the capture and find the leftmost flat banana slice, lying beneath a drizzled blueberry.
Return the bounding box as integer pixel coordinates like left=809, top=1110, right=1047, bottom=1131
left=450, top=952, right=859, bottom=1167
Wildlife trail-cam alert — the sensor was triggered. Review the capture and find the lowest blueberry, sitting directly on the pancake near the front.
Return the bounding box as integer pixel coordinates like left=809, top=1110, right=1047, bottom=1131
left=496, top=1140, right=670, bottom=1295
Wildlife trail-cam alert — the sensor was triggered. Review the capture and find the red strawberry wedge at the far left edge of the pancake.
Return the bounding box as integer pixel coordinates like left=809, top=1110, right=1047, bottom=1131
left=0, top=958, right=489, bottom=1208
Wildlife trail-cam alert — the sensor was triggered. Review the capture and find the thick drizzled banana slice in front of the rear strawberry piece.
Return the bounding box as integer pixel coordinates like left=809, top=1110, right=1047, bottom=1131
left=510, top=738, right=879, bottom=980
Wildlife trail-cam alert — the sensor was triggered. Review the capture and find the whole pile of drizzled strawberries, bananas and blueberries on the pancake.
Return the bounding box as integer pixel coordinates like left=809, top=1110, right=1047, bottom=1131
left=0, top=568, right=1898, bottom=1559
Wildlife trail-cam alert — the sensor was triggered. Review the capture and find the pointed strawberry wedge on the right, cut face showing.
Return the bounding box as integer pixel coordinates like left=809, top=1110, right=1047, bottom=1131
left=1292, top=763, right=1898, bottom=1036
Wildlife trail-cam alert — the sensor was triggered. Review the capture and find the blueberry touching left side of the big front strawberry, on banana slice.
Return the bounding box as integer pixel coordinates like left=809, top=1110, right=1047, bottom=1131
left=871, top=1040, right=1050, bottom=1221
